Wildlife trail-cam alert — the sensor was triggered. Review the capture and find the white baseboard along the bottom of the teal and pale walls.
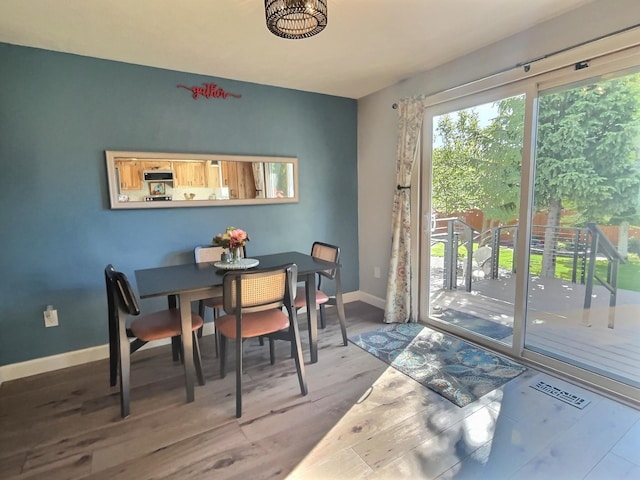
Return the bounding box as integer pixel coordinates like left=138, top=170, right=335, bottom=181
left=0, top=291, right=384, bottom=385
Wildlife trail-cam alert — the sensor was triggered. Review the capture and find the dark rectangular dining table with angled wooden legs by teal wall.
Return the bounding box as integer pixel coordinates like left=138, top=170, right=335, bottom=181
left=134, top=252, right=347, bottom=402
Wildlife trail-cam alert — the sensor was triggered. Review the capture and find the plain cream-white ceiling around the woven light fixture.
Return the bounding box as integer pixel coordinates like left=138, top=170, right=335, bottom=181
left=0, top=0, right=594, bottom=99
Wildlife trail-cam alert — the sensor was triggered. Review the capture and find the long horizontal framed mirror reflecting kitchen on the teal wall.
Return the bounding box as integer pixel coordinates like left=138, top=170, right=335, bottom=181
left=105, top=150, right=298, bottom=208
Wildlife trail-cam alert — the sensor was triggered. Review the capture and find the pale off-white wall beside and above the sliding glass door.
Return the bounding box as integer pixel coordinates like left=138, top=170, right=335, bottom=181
left=358, top=0, right=640, bottom=300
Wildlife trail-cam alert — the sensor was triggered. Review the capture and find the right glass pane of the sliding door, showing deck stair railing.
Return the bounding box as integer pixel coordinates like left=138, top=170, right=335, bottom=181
left=525, top=66, right=640, bottom=388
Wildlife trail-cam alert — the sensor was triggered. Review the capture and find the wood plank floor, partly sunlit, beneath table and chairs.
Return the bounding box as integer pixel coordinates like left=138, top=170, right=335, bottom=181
left=0, top=302, right=640, bottom=480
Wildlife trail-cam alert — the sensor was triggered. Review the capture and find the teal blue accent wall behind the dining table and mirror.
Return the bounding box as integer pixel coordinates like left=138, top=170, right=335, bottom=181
left=0, top=44, right=358, bottom=365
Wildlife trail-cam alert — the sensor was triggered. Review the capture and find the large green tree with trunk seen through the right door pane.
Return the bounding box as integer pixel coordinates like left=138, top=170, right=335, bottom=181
left=535, top=75, right=640, bottom=276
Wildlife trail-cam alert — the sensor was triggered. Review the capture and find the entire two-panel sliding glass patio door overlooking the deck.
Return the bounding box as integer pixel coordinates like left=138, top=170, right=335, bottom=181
left=419, top=47, right=640, bottom=399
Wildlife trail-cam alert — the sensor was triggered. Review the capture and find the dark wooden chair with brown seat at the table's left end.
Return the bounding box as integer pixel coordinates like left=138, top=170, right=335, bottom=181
left=104, top=265, right=204, bottom=418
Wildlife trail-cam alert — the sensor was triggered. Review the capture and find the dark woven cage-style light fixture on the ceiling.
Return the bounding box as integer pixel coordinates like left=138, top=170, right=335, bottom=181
left=264, top=0, right=327, bottom=39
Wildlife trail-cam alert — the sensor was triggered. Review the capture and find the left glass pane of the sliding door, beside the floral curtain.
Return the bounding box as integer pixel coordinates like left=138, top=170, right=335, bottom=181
left=425, top=93, right=525, bottom=345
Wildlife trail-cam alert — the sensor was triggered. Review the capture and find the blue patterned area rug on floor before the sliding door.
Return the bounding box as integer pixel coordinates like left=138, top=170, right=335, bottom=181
left=349, top=323, right=526, bottom=407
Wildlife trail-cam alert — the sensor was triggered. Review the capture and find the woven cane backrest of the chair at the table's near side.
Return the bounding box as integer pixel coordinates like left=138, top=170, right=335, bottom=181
left=222, top=264, right=298, bottom=315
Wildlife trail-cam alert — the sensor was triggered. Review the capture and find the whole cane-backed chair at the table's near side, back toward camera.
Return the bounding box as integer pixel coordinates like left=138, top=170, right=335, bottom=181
left=216, top=264, right=307, bottom=418
